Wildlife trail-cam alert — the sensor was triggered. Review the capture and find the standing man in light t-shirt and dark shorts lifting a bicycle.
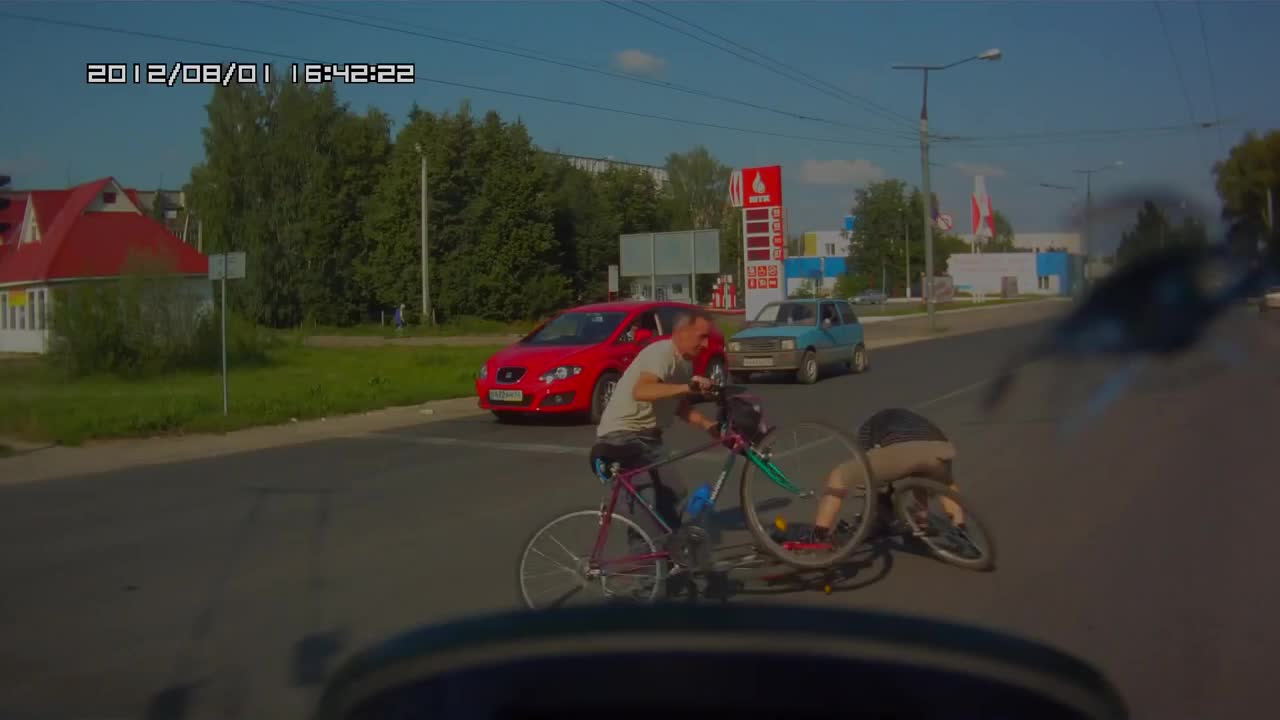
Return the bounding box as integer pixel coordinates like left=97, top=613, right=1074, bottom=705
left=591, top=309, right=719, bottom=538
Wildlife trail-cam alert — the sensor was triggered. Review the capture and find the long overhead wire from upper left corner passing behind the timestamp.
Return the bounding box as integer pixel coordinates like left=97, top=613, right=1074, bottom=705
left=0, top=12, right=911, bottom=150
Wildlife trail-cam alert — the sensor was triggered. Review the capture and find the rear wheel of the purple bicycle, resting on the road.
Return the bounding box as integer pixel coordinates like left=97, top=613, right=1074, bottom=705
left=516, top=509, right=667, bottom=610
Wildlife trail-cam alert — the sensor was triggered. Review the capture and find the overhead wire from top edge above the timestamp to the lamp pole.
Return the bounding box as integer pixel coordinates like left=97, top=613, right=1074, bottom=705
left=239, top=0, right=911, bottom=140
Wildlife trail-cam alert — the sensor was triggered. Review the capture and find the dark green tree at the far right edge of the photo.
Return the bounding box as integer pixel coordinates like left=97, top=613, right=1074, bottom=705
left=1213, top=131, right=1280, bottom=254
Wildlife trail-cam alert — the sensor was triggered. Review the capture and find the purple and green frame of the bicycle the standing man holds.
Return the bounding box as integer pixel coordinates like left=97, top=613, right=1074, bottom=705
left=590, top=428, right=804, bottom=569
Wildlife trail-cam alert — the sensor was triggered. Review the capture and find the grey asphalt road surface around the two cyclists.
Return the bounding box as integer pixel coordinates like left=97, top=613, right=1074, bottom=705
left=0, top=304, right=1280, bottom=720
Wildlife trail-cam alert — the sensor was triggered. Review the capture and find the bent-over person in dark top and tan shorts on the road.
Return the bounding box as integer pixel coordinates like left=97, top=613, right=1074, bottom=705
left=810, top=407, right=964, bottom=543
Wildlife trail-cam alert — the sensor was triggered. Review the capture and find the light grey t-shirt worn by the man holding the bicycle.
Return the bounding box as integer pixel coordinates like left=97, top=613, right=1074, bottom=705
left=595, top=340, right=694, bottom=437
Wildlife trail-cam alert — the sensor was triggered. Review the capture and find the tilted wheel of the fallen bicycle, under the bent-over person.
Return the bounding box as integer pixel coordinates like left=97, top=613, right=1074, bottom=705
left=893, top=478, right=996, bottom=571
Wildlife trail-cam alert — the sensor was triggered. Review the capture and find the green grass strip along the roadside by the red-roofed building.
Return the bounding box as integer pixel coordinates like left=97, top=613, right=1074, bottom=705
left=0, top=346, right=497, bottom=445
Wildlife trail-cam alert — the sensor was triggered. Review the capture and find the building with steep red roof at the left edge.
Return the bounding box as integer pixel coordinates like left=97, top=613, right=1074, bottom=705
left=0, top=178, right=212, bottom=352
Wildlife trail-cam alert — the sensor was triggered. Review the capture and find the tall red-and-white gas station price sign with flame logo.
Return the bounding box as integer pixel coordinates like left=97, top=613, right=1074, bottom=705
left=728, top=165, right=786, bottom=319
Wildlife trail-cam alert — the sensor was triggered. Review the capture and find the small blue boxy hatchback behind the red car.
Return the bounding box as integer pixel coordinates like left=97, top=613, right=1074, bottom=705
left=724, top=299, right=869, bottom=384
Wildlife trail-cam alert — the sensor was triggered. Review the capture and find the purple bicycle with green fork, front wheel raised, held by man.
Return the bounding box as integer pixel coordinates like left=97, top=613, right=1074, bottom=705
left=517, top=386, right=876, bottom=610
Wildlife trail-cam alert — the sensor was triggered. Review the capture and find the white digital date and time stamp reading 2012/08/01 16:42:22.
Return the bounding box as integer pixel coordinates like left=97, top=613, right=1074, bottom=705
left=84, top=61, right=416, bottom=87
